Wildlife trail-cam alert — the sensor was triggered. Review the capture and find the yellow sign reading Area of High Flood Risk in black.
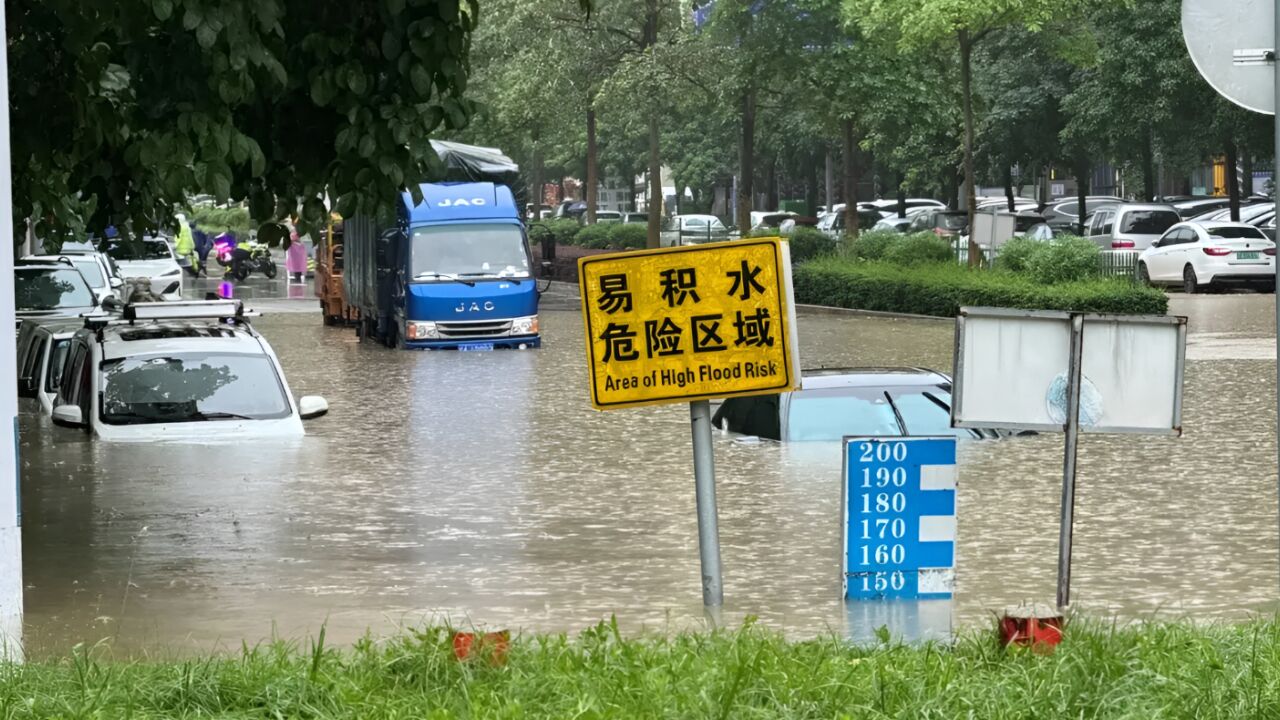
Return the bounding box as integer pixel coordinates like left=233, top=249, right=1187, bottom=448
left=579, top=238, right=800, bottom=410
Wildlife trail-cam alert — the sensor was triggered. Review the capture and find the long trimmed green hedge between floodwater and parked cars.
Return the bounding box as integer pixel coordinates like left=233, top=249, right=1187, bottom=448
left=792, top=258, right=1169, bottom=318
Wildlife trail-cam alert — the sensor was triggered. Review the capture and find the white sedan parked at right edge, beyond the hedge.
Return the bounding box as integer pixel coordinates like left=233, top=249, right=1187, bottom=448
left=1138, top=222, right=1276, bottom=292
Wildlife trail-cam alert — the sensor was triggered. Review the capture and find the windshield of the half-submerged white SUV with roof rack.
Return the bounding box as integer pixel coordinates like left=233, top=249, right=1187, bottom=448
left=102, top=352, right=291, bottom=425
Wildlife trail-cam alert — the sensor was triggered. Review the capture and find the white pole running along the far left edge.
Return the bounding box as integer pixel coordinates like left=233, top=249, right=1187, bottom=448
left=0, top=0, right=22, bottom=661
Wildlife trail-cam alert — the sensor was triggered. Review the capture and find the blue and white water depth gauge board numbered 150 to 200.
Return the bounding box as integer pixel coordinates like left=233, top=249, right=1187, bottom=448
left=841, top=437, right=956, bottom=600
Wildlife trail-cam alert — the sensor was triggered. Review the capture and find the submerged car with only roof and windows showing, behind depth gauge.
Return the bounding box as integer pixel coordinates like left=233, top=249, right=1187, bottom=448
left=712, top=368, right=1006, bottom=442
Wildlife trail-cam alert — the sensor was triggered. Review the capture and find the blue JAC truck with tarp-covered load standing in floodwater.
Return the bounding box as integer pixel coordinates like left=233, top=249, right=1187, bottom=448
left=343, top=143, right=541, bottom=350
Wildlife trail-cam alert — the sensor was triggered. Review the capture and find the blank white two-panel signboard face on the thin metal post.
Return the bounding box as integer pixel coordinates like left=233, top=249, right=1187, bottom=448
left=951, top=307, right=1187, bottom=434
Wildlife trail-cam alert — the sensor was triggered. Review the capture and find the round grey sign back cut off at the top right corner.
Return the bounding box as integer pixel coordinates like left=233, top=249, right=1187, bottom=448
left=1183, top=0, right=1276, bottom=115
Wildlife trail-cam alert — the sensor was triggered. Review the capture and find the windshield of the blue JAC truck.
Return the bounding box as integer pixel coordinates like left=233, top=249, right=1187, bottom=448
left=410, top=224, right=529, bottom=279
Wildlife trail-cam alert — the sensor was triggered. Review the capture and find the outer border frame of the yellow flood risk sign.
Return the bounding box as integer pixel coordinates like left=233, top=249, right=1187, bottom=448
left=577, top=237, right=800, bottom=410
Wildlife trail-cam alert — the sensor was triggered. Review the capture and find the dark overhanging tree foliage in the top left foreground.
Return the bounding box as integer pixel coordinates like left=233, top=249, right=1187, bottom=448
left=8, top=0, right=479, bottom=242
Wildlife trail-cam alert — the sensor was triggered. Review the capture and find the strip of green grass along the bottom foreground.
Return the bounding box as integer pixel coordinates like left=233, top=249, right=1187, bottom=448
left=0, top=621, right=1280, bottom=720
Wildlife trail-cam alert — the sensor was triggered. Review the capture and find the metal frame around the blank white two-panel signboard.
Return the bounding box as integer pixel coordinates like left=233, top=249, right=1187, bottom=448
left=951, top=307, right=1187, bottom=437
